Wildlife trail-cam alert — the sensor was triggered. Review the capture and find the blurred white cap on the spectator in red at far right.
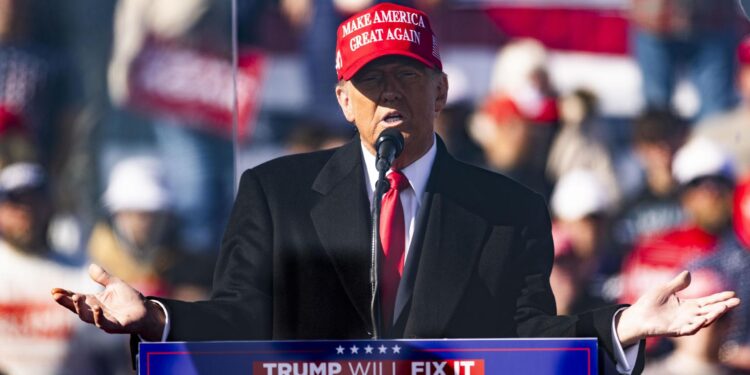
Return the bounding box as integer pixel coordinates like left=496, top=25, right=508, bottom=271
left=672, top=137, right=734, bottom=185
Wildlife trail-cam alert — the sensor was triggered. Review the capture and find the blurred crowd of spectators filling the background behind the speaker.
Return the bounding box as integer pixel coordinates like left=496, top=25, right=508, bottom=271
left=0, top=0, right=750, bottom=374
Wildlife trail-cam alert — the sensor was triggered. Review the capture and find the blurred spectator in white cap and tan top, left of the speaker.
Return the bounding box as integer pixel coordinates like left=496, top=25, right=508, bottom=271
left=88, top=156, right=212, bottom=300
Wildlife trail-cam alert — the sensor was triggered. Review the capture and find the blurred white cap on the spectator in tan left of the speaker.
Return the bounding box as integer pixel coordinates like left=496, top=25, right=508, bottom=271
left=102, top=156, right=172, bottom=213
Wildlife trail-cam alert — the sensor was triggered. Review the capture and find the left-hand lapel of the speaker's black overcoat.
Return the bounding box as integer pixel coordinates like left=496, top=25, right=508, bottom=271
left=310, top=138, right=371, bottom=327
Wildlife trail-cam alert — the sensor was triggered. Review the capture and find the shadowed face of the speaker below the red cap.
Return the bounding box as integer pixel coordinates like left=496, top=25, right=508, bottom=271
left=336, top=56, right=448, bottom=169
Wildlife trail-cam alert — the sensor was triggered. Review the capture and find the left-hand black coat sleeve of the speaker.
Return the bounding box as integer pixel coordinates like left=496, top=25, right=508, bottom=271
left=159, top=170, right=273, bottom=341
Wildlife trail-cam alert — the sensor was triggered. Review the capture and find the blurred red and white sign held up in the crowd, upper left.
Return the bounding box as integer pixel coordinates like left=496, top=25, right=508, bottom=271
left=127, top=38, right=266, bottom=138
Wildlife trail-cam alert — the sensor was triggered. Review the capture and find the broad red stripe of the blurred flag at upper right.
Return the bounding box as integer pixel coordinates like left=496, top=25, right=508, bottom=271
left=486, top=6, right=629, bottom=54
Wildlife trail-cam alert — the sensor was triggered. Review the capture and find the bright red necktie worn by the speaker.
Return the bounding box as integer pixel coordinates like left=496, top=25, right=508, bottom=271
left=380, top=170, right=409, bottom=327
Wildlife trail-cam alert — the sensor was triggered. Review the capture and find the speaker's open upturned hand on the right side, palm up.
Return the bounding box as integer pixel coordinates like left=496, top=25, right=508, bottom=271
left=616, top=271, right=740, bottom=347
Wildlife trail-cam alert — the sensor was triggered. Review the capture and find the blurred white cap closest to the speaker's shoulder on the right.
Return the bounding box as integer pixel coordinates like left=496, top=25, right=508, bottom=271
left=551, top=169, right=611, bottom=220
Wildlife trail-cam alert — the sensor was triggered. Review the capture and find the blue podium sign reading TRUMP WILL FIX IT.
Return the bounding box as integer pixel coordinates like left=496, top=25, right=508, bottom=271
left=138, top=339, right=597, bottom=375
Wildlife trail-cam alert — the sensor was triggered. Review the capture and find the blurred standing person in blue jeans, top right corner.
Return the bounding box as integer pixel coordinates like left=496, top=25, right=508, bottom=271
left=630, top=0, right=739, bottom=118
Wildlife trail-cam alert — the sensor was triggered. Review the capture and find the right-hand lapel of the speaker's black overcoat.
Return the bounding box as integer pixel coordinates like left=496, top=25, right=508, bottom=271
left=397, top=141, right=491, bottom=337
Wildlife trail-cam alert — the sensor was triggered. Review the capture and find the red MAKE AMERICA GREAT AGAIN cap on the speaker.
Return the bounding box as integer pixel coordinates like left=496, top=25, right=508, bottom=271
left=336, top=3, right=443, bottom=80
